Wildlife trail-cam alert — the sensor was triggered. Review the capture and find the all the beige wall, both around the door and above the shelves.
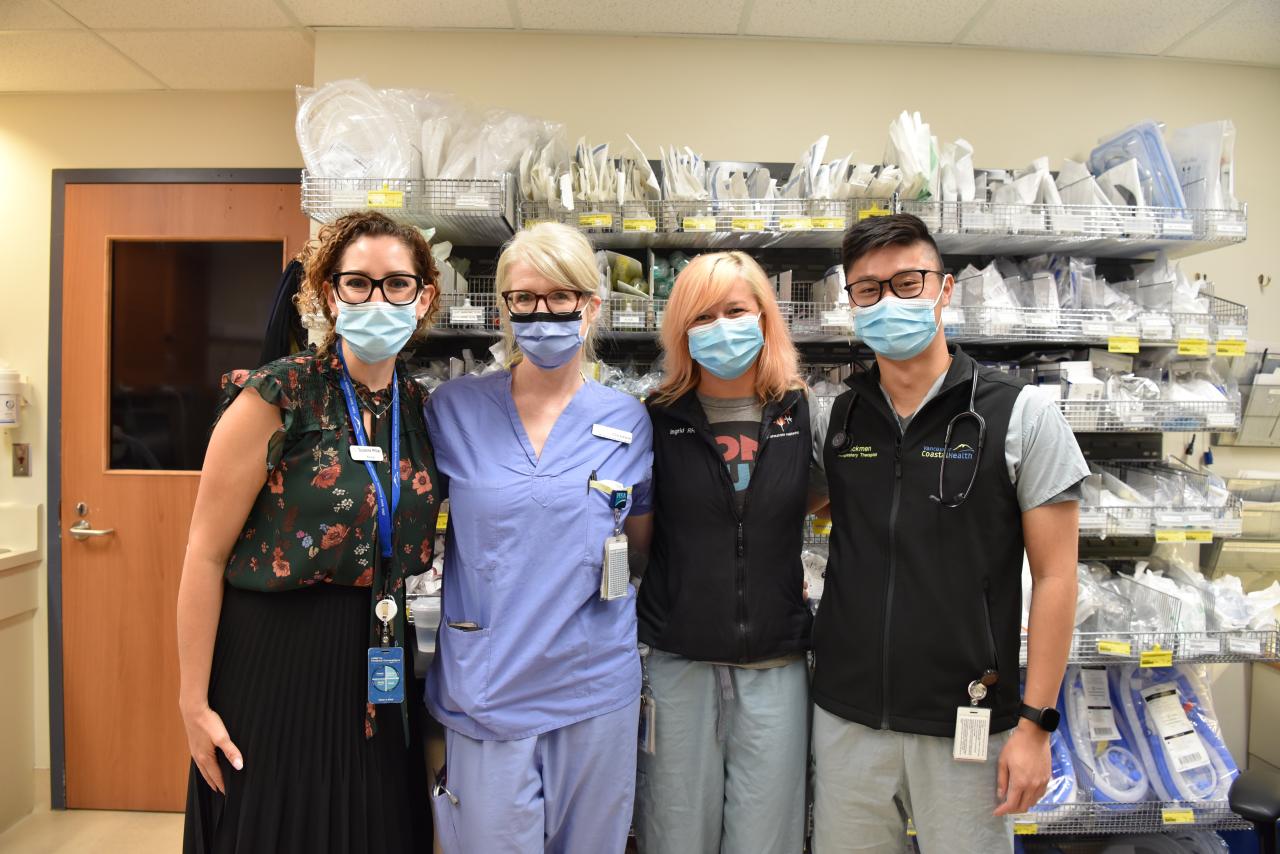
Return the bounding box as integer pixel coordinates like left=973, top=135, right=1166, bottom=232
left=0, top=31, right=1280, bottom=814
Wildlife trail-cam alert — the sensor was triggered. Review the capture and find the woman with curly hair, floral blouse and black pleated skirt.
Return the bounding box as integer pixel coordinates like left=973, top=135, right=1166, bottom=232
left=178, top=213, right=439, bottom=854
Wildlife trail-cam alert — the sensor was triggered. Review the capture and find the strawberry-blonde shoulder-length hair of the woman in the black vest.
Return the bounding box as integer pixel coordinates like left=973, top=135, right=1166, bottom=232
left=654, top=252, right=808, bottom=405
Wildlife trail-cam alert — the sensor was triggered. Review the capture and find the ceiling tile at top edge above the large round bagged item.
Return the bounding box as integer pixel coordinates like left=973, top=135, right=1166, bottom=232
left=284, top=0, right=516, bottom=29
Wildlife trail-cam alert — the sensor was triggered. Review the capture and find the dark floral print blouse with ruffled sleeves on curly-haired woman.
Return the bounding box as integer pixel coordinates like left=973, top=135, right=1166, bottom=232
left=218, top=351, right=439, bottom=594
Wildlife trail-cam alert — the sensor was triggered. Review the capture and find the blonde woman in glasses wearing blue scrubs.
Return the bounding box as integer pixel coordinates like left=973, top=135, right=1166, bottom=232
left=426, top=223, right=653, bottom=854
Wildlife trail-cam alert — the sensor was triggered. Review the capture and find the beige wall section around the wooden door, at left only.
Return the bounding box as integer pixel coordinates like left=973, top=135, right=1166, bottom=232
left=0, top=92, right=301, bottom=798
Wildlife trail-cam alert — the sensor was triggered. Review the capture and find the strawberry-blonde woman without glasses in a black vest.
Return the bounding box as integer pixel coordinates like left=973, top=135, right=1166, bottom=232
left=636, top=252, right=810, bottom=854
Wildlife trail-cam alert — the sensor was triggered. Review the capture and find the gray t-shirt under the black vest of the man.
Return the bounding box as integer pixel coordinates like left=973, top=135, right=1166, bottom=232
left=810, top=371, right=1089, bottom=512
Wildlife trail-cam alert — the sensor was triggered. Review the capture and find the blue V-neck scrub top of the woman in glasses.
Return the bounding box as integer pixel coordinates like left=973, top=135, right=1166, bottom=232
left=426, top=371, right=653, bottom=740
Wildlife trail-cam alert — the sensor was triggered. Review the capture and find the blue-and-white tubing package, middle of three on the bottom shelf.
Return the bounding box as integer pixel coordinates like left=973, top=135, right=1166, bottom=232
left=1062, top=667, right=1155, bottom=809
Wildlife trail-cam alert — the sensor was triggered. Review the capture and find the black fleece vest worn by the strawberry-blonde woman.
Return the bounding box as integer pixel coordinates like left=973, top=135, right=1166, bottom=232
left=636, top=392, right=812, bottom=663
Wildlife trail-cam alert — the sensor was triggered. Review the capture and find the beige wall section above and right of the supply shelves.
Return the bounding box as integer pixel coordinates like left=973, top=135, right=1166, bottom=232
left=315, top=31, right=1280, bottom=472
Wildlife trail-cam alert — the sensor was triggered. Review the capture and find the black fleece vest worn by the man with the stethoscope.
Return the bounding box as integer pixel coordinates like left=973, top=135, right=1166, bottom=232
left=813, top=348, right=1023, bottom=736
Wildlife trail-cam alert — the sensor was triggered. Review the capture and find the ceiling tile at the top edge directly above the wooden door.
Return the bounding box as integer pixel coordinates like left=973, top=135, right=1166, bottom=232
left=54, top=0, right=293, bottom=29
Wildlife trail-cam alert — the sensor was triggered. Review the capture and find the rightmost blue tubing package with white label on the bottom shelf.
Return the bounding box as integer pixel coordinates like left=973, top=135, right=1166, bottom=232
left=1112, top=665, right=1240, bottom=800
